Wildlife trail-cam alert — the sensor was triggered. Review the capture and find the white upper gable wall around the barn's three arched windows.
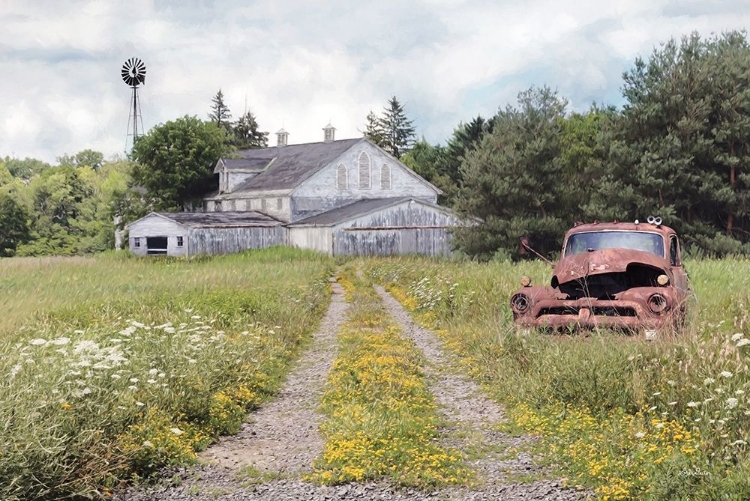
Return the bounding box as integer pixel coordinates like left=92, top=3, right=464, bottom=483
left=291, top=142, right=438, bottom=221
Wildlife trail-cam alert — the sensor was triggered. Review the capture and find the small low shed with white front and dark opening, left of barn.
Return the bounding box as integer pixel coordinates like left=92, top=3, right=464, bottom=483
left=127, top=212, right=288, bottom=256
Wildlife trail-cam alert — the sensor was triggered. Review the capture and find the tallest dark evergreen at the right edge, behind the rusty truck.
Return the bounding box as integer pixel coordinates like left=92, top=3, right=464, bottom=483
left=600, top=32, right=750, bottom=254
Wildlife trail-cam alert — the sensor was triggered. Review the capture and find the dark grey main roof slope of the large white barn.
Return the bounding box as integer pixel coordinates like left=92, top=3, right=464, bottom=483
left=214, top=138, right=366, bottom=192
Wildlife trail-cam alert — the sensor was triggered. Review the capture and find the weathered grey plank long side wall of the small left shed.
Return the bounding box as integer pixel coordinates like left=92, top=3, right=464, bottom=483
left=189, top=226, right=288, bottom=256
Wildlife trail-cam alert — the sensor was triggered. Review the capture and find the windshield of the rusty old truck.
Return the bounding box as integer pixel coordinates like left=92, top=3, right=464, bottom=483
left=565, top=231, right=664, bottom=257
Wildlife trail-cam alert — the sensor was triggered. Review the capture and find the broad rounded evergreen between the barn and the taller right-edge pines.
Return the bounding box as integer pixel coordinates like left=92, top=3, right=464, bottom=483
left=456, top=87, right=573, bottom=257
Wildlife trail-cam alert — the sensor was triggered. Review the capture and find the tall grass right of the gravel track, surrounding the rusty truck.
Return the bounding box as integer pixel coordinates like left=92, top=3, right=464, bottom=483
left=365, top=259, right=750, bottom=499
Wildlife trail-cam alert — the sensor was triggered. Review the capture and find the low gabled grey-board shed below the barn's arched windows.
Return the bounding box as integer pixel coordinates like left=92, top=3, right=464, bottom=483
left=288, top=198, right=460, bottom=256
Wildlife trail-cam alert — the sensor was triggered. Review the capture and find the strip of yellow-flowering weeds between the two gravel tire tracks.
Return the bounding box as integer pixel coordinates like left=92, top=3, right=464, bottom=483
left=310, top=268, right=471, bottom=487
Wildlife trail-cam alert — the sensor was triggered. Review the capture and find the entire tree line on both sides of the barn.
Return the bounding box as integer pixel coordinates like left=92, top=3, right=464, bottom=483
left=0, top=31, right=750, bottom=258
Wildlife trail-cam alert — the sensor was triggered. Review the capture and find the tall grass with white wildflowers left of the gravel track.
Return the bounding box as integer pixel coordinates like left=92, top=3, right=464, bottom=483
left=0, top=249, right=332, bottom=500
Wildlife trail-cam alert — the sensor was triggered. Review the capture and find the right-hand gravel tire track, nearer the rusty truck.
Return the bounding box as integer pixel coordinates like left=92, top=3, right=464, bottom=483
left=374, top=285, right=585, bottom=500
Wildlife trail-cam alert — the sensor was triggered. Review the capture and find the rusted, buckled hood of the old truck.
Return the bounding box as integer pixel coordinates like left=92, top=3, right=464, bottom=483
left=554, top=249, right=669, bottom=284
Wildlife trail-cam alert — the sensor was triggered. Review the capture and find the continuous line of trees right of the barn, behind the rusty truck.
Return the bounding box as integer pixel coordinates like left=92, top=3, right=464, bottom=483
left=403, top=31, right=750, bottom=258
